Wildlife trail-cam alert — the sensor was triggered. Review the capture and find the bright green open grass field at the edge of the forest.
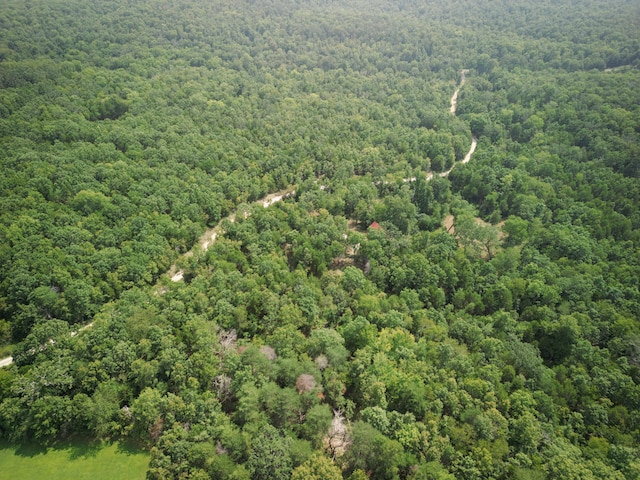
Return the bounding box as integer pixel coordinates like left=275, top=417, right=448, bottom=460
left=0, top=440, right=149, bottom=480
